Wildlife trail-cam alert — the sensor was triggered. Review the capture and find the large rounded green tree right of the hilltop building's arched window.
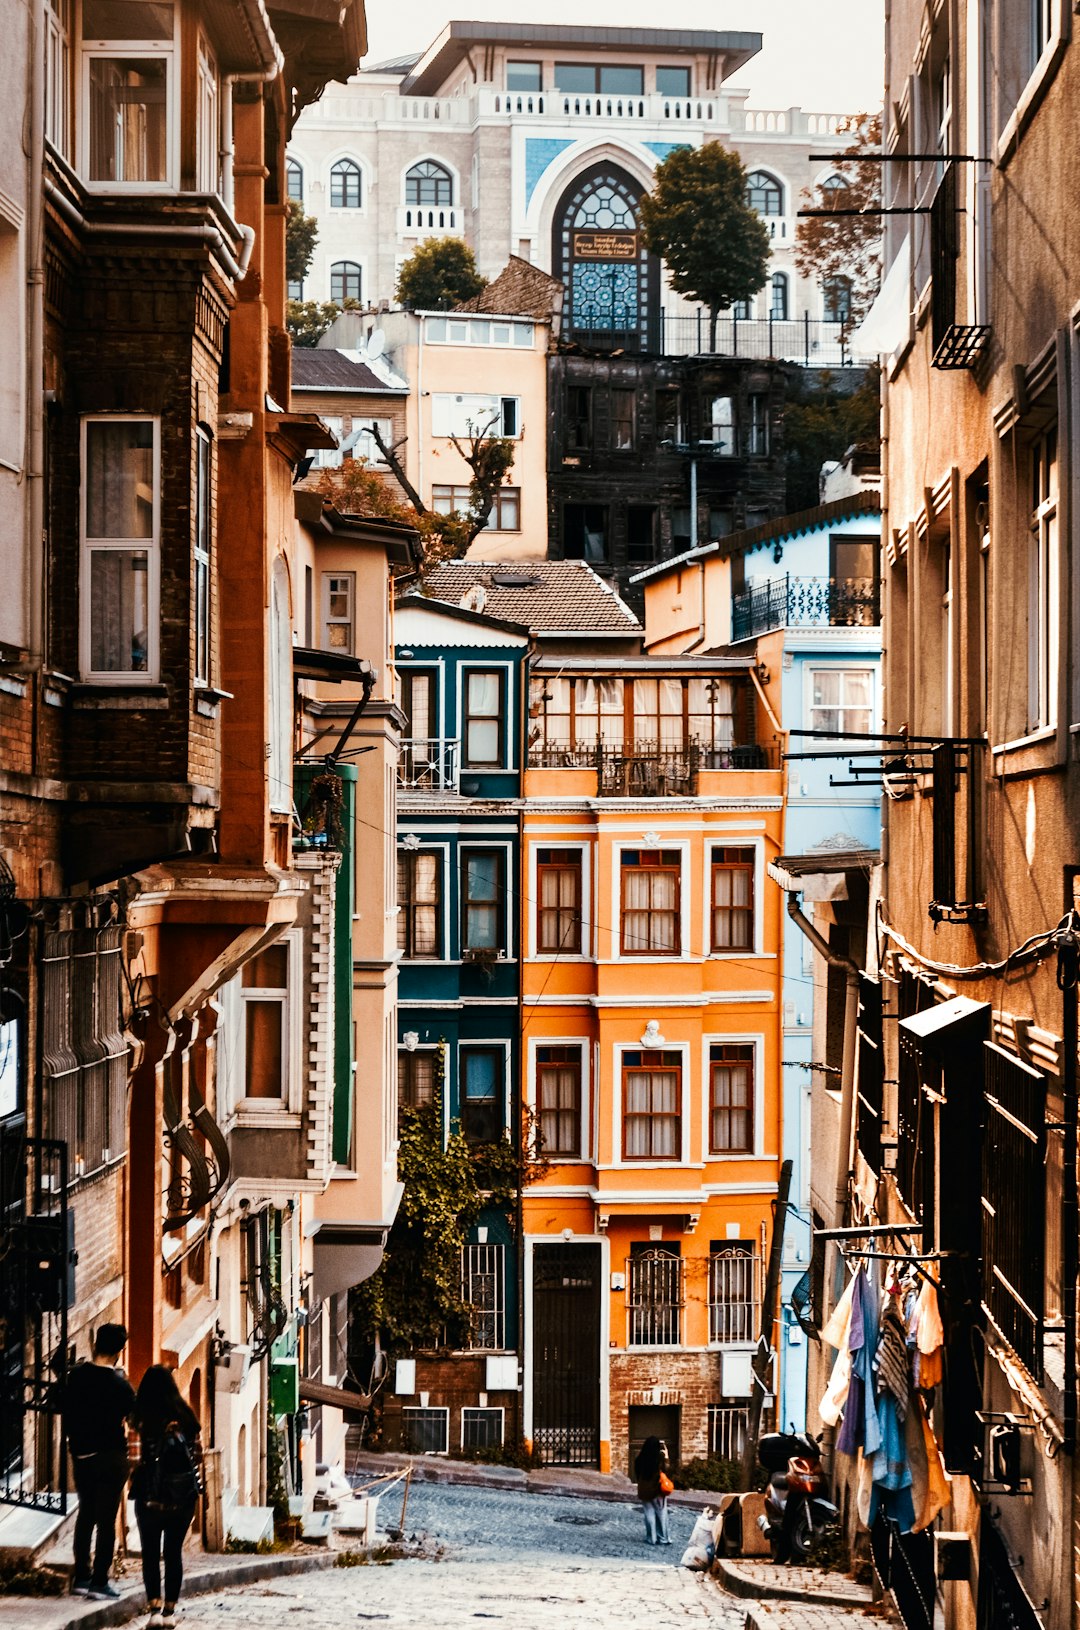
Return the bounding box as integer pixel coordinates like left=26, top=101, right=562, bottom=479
left=640, top=142, right=769, bottom=350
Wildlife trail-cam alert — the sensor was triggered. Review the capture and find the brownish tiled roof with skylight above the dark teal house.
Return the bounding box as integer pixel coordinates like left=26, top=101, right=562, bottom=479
left=424, top=561, right=642, bottom=637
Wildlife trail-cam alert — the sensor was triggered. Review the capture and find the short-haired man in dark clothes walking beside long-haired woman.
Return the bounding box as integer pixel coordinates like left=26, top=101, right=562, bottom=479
left=64, top=1325, right=135, bottom=1602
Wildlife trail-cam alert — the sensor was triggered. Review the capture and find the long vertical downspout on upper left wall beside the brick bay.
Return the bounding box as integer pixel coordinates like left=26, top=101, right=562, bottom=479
left=24, top=0, right=47, bottom=668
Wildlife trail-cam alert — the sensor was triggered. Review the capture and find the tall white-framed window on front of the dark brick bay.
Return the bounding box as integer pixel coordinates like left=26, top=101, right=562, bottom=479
left=80, top=416, right=161, bottom=681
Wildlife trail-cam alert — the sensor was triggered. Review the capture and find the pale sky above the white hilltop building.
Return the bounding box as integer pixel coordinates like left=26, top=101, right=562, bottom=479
left=367, top=0, right=885, bottom=112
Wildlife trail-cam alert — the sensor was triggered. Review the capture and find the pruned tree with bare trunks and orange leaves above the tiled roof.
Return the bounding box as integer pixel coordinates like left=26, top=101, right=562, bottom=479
left=319, top=407, right=515, bottom=575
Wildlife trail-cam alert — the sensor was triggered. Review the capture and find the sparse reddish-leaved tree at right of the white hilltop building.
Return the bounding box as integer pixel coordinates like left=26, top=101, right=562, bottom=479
left=795, top=112, right=881, bottom=323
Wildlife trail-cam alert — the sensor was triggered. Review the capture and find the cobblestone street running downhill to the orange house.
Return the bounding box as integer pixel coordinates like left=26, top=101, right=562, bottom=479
left=184, top=1485, right=746, bottom=1630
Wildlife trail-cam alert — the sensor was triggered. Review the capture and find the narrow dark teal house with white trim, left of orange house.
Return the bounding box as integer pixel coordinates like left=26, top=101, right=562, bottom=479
left=383, top=595, right=529, bottom=1452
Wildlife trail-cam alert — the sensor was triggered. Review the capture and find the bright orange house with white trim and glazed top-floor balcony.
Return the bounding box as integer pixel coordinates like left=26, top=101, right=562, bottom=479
left=521, top=639, right=782, bottom=1470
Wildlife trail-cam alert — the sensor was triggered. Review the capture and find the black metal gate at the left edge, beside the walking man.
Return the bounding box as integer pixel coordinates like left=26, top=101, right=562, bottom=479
left=0, top=1123, right=75, bottom=1513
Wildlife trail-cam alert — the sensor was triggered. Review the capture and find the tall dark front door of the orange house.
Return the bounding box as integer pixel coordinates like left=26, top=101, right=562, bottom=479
left=533, top=1245, right=601, bottom=1465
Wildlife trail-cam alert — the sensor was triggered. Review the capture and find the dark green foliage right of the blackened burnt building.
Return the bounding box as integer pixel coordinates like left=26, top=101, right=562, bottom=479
left=784, top=363, right=880, bottom=513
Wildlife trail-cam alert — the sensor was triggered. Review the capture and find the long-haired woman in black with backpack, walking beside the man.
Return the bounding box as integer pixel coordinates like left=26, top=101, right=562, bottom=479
left=132, top=1364, right=200, bottom=1625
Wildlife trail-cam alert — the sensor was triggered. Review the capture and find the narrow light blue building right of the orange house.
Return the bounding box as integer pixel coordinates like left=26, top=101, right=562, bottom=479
left=725, top=487, right=881, bottom=1426
